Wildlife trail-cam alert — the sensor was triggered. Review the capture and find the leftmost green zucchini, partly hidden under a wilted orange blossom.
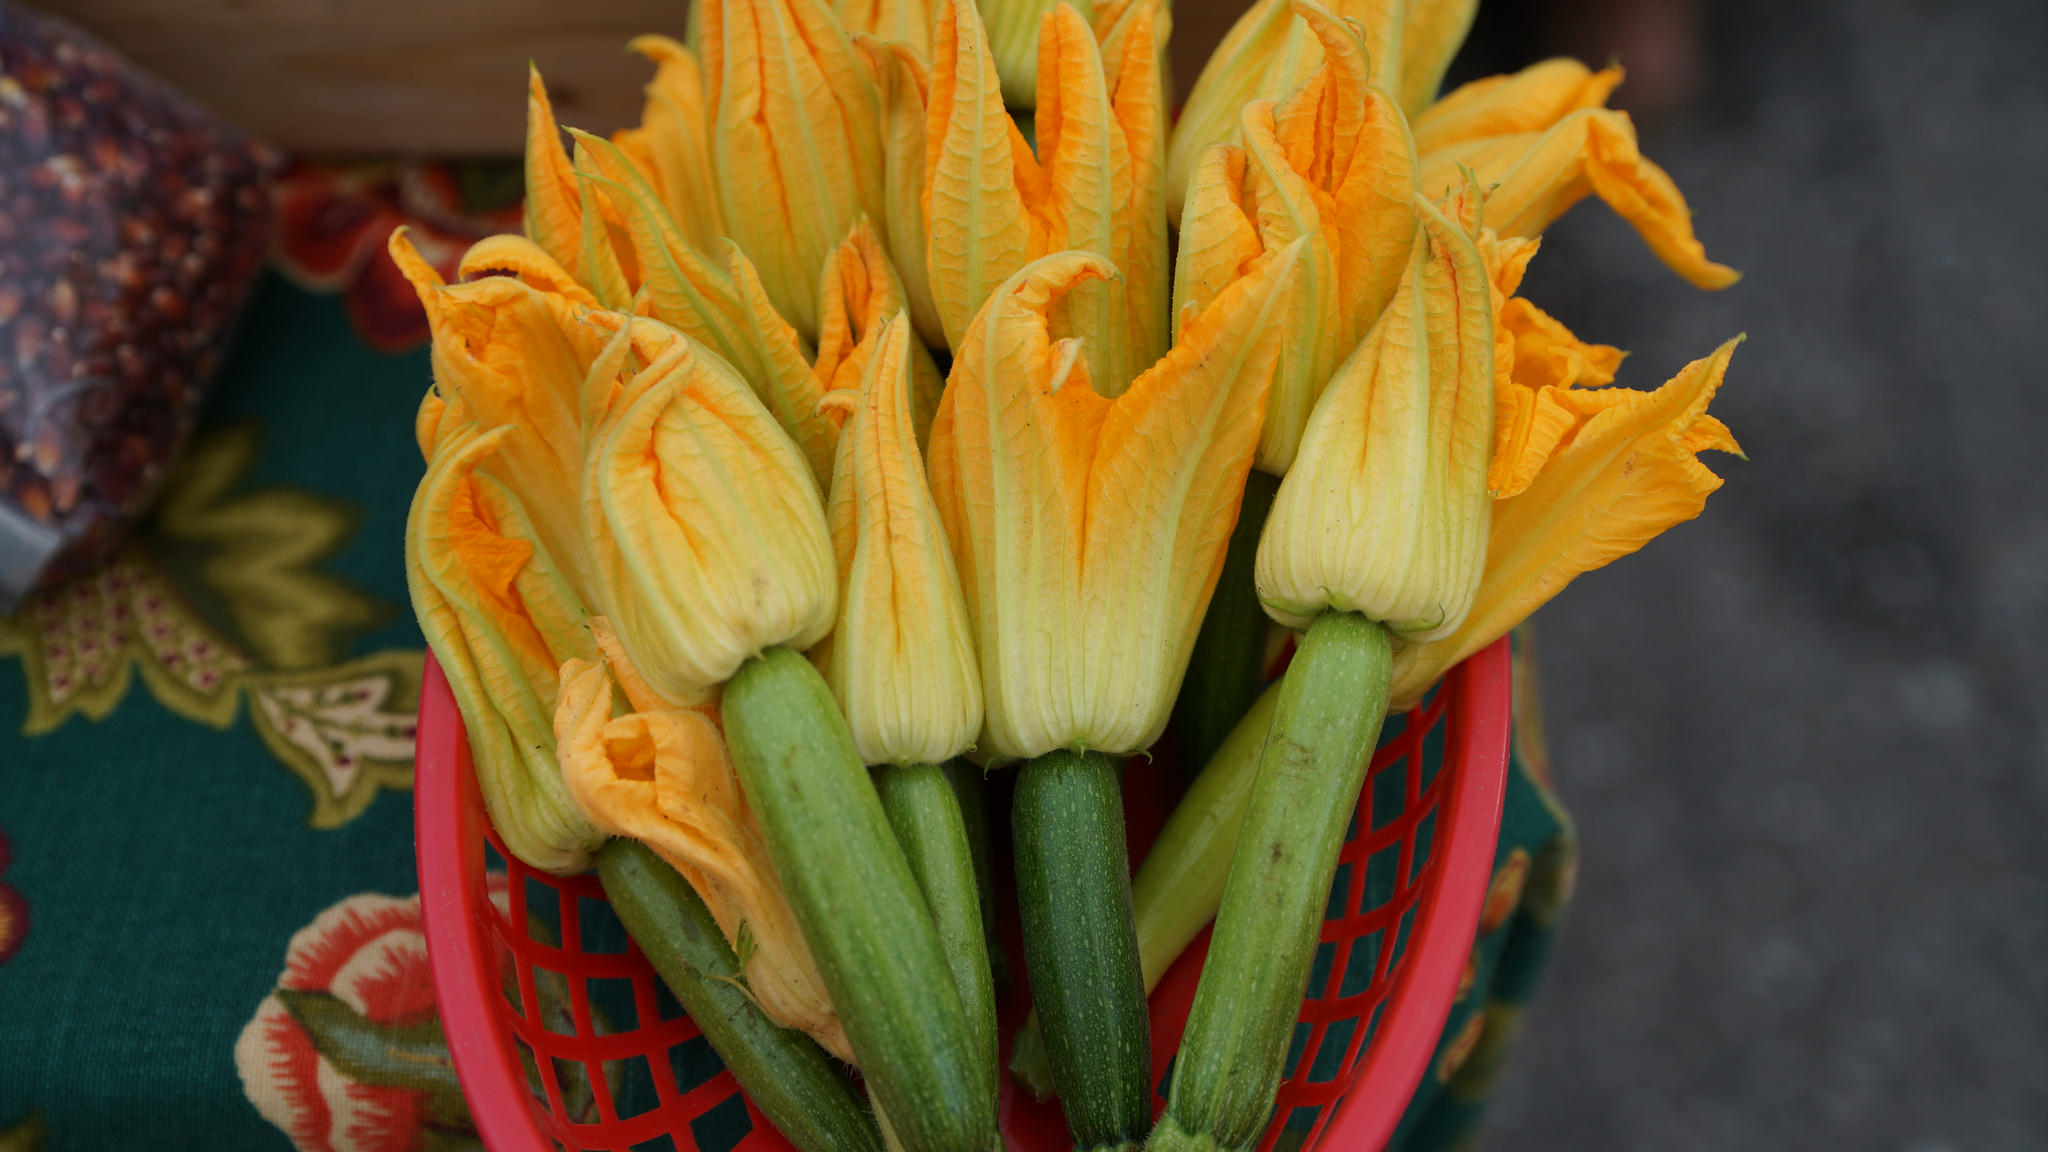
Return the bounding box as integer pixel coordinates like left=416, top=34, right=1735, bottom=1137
left=598, top=838, right=883, bottom=1152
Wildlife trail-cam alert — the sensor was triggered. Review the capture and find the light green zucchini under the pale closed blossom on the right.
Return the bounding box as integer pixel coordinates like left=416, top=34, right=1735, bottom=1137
left=1151, top=613, right=1393, bottom=1152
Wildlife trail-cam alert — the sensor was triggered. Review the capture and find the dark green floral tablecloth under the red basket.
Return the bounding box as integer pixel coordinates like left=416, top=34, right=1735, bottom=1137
left=0, top=170, right=1573, bottom=1152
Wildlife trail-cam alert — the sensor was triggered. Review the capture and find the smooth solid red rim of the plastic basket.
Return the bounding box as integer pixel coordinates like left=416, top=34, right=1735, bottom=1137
left=414, top=637, right=1513, bottom=1152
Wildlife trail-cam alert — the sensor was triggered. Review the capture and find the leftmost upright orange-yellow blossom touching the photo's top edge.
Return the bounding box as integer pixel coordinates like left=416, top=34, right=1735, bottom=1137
left=700, top=0, right=883, bottom=336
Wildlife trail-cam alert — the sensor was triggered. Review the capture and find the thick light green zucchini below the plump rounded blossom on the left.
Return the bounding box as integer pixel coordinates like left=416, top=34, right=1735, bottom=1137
left=721, top=648, right=1001, bottom=1152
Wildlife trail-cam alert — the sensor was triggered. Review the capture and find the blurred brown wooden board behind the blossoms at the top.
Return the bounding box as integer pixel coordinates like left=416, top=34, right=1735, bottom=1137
left=39, top=0, right=1245, bottom=156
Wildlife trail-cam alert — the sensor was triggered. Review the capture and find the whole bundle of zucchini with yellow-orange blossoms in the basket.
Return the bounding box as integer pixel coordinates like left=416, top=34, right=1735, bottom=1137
left=403, top=0, right=1735, bottom=1152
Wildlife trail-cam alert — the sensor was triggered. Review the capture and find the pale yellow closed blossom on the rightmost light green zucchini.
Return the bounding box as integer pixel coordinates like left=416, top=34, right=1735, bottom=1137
left=1255, top=197, right=1495, bottom=642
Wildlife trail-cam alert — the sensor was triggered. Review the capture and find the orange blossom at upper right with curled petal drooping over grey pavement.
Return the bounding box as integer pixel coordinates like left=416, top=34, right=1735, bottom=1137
left=1415, top=59, right=1739, bottom=289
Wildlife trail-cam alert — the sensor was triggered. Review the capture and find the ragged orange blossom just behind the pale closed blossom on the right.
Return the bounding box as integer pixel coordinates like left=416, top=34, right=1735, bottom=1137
left=1174, top=0, right=1415, bottom=476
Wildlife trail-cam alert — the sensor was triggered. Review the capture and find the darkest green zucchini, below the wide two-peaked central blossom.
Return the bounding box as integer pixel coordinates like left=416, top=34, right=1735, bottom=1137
left=1012, top=750, right=1153, bottom=1152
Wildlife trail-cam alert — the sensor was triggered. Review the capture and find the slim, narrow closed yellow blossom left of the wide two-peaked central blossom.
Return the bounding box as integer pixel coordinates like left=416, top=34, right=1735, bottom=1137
left=813, top=312, right=981, bottom=765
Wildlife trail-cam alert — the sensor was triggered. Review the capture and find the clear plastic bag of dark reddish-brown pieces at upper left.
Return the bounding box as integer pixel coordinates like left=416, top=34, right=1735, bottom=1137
left=0, top=0, right=274, bottom=613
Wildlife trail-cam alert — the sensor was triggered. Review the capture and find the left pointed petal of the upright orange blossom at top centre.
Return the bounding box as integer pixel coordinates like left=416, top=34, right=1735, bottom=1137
left=924, top=0, right=1042, bottom=348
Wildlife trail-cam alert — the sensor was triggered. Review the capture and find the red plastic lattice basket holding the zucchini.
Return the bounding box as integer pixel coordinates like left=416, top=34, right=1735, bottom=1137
left=414, top=640, right=1511, bottom=1152
